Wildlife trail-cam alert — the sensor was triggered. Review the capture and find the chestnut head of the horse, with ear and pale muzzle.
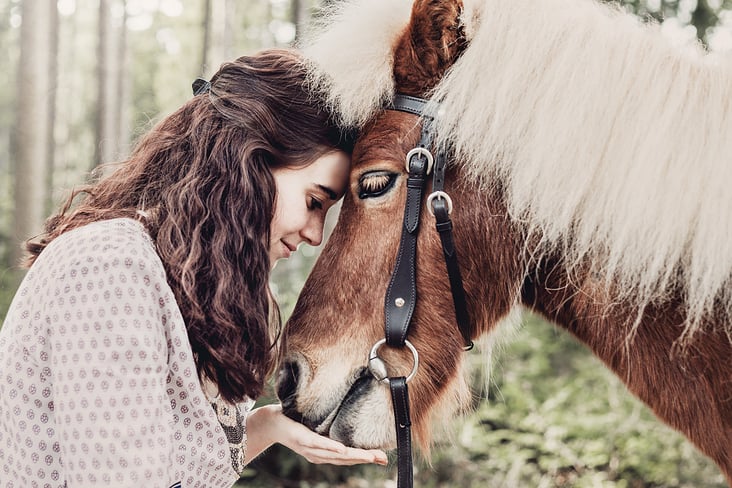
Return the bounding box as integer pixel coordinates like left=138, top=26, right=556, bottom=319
left=277, top=0, right=521, bottom=448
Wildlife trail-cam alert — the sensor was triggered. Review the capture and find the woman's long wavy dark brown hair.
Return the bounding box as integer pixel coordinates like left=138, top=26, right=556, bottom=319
left=26, top=49, right=351, bottom=402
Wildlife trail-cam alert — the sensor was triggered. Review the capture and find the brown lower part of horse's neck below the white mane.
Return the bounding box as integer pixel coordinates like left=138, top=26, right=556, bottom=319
left=522, top=261, right=732, bottom=481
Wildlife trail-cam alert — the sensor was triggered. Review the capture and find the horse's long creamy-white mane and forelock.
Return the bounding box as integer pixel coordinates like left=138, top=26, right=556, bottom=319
left=302, top=0, right=732, bottom=333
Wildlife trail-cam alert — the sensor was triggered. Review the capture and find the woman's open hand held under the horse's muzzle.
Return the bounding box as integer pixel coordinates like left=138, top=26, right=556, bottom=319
left=246, top=405, right=387, bottom=465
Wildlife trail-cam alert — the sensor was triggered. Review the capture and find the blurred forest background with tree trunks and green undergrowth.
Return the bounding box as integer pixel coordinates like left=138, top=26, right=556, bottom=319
left=0, top=0, right=732, bottom=488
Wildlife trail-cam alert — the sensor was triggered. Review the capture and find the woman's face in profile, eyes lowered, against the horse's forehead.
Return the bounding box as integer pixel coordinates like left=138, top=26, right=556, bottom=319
left=269, top=151, right=351, bottom=266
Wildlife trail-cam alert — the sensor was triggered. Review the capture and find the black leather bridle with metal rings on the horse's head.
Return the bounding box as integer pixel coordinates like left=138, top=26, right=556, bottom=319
left=369, top=94, right=473, bottom=488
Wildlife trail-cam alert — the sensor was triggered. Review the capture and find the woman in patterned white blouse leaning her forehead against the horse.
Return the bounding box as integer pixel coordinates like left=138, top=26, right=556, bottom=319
left=0, top=50, right=386, bottom=487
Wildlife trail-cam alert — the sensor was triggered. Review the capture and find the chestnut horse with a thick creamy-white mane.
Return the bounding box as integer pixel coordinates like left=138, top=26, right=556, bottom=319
left=276, top=0, right=732, bottom=484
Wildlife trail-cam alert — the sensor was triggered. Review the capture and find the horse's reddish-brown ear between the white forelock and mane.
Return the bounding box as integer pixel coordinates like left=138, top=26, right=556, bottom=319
left=394, top=0, right=467, bottom=96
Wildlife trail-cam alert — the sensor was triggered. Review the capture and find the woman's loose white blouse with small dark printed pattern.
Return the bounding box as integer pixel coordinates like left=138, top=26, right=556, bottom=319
left=0, top=219, right=251, bottom=488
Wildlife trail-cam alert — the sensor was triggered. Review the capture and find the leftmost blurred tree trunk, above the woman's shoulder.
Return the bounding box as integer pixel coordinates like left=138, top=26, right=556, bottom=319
left=11, top=0, right=56, bottom=264
